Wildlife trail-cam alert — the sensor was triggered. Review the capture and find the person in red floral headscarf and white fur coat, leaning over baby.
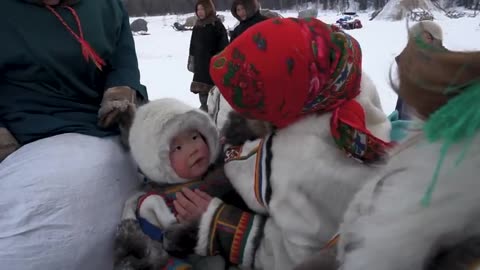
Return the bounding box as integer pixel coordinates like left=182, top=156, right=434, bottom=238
left=164, top=18, right=402, bottom=270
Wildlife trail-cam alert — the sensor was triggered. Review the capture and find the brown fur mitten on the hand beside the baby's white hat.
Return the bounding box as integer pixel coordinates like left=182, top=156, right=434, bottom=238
left=98, top=86, right=139, bottom=148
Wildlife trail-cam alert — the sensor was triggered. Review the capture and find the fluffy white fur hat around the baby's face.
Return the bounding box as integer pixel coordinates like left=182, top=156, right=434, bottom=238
left=129, top=98, right=220, bottom=184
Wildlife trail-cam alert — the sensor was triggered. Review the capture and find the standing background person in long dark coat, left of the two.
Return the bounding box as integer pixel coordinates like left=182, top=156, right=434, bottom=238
left=187, top=0, right=228, bottom=112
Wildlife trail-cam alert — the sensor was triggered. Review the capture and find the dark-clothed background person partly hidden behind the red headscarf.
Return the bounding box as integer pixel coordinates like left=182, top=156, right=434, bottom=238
left=230, top=0, right=268, bottom=42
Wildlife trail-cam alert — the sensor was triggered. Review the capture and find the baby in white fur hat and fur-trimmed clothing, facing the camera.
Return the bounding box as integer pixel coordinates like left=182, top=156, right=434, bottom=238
left=115, top=98, right=245, bottom=269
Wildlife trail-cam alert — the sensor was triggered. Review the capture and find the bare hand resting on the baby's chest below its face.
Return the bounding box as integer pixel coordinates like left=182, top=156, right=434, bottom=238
left=173, top=188, right=212, bottom=223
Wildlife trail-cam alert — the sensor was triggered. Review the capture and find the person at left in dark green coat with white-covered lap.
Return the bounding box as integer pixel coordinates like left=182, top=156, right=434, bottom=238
left=0, top=0, right=148, bottom=270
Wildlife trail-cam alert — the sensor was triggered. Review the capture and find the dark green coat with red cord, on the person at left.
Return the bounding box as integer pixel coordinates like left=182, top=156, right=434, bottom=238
left=0, top=0, right=147, bottom=144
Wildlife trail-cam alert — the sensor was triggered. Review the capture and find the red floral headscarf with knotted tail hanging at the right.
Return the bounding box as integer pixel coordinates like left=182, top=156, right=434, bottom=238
left=210, top=18, right=390, bottom=165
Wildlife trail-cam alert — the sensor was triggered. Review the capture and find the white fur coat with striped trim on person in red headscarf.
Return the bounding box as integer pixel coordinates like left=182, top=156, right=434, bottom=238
left=219, top=114, right=384, bottom=269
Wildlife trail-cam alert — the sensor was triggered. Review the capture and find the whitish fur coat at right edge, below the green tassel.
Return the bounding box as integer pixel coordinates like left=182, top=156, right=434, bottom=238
left=338, top=135, right=480, bottom=270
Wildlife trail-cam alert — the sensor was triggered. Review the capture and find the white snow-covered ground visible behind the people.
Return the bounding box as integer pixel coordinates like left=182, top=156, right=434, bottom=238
left=132, top=12, right=480, bottom=113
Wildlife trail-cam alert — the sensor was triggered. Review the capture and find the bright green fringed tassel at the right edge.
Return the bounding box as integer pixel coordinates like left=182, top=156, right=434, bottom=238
left=422, top=82, right=480, bottom=206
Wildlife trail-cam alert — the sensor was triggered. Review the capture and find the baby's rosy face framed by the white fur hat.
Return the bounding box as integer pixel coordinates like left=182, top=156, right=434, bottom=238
left=170, top=130, right=210, bottom=180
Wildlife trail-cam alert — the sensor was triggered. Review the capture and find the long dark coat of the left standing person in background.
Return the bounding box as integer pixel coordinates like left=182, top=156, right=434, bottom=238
left=190, top=18, right=228, bottom=89
